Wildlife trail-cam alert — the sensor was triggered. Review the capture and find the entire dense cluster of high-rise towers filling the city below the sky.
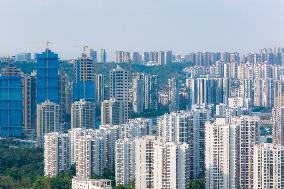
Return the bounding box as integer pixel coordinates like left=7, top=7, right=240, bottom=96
left=0, top=48, right=284, bottom=189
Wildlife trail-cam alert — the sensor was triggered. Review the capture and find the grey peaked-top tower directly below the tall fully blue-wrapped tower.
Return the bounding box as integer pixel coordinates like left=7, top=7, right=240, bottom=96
left=37, top=100, right=61, bottom=147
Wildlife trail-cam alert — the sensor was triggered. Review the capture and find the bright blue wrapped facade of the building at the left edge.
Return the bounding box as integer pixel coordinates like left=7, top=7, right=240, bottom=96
left=0, top=75, right=23, bottom=137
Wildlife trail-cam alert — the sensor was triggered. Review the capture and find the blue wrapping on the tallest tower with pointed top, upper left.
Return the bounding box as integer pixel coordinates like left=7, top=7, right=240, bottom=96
left=36, top=49, right=59, bottom=103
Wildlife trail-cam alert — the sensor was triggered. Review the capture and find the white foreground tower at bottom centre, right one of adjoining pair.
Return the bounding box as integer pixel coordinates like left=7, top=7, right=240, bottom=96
left=153, top=141, right=189, bottom=189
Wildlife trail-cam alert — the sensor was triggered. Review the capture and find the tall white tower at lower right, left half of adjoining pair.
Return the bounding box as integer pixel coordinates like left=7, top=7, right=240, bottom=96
left=205, top=118, right=234, bottom=189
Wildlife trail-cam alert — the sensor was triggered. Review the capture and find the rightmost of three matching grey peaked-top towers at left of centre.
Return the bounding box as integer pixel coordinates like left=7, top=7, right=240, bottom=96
left=101, top=98, right=123, bottom=125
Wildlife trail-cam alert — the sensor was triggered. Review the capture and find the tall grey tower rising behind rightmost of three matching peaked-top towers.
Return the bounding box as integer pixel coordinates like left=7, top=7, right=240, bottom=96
left=110, top=66, right=130, bottom=123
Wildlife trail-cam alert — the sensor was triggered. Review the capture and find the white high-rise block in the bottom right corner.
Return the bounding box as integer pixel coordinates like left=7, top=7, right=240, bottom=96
left=253, top=143, right=284, bottom=189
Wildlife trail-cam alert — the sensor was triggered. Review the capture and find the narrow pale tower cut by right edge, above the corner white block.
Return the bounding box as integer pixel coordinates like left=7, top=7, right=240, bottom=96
left=272, top=106, right=284, bottom=145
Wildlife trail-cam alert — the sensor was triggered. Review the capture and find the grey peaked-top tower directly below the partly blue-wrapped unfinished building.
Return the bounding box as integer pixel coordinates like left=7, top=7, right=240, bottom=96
left=71, top=99, right=96, bottom=129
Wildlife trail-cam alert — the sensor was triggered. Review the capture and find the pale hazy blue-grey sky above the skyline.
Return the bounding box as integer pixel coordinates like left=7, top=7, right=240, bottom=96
left=0, top=0, right=284, bottom=58
